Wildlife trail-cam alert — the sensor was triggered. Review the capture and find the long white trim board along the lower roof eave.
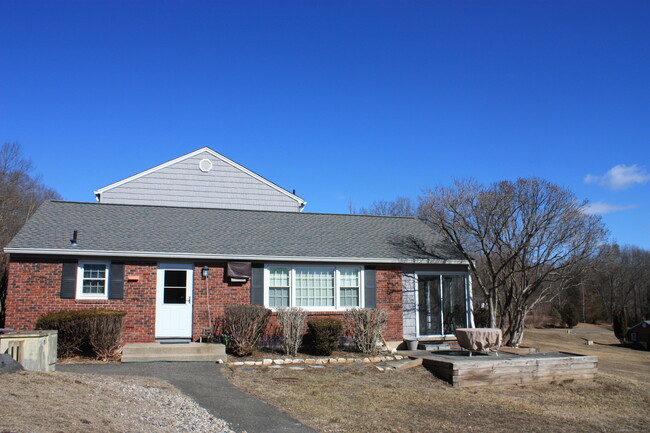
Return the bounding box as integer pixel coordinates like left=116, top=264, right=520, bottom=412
left=4, top=248, right=469, bottom=265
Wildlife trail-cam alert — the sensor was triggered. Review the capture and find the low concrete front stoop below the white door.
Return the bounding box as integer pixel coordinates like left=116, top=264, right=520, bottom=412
left=122, top=343, right=226, bottom=362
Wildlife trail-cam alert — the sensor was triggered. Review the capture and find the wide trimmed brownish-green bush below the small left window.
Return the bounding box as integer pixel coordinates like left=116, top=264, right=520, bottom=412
left=36, top=309, right=126, bottom=359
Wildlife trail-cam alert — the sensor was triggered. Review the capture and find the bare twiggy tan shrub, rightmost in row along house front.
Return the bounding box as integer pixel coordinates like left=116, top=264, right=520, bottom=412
left=345, top=308, right=388, bottom=354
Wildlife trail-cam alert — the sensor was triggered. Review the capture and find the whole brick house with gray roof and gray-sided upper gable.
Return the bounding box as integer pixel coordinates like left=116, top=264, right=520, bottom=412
left=5, top=148, right=473, bottom=342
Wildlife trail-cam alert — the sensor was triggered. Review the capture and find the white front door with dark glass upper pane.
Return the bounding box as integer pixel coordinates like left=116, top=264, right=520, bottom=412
left=156, top=263, right=194, bottom=338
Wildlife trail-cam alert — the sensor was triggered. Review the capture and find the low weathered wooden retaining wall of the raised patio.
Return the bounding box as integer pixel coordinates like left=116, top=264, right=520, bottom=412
left=423, top=354, right=598, bottom=387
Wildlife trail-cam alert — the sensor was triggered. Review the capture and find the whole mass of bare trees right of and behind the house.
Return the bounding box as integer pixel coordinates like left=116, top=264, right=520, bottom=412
left=358, top=178, right=650, bottom=346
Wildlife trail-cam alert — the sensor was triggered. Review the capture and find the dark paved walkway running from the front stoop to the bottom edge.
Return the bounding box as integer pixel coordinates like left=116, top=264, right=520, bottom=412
left=56, top=362, right=315, bottom=433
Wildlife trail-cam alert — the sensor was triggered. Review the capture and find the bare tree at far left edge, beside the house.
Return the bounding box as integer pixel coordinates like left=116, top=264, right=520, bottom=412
left=0, top=143, right=60, bottom=325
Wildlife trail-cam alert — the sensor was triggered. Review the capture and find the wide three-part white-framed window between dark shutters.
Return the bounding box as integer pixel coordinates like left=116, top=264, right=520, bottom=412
left=264, top=265, right=363, bottom=311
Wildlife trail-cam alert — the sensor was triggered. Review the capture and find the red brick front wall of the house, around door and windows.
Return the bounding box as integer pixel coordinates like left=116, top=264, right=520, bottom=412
left=5, top=259, right=402, bottom=343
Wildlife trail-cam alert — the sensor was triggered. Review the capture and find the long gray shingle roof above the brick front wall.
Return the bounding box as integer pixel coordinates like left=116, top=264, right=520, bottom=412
left=6, top=201, right=462, bottom=262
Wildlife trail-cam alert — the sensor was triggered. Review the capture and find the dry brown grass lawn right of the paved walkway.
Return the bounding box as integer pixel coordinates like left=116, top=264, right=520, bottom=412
left=224, top=329, right=650, bottom=433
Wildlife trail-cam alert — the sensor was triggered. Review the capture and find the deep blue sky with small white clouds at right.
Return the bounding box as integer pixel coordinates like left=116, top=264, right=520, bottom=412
left=0, top=0, right=650, bottom=248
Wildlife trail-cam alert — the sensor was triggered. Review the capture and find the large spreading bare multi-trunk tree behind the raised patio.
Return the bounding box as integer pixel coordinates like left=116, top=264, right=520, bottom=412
left=419, top=178, right=606, bottom=346
